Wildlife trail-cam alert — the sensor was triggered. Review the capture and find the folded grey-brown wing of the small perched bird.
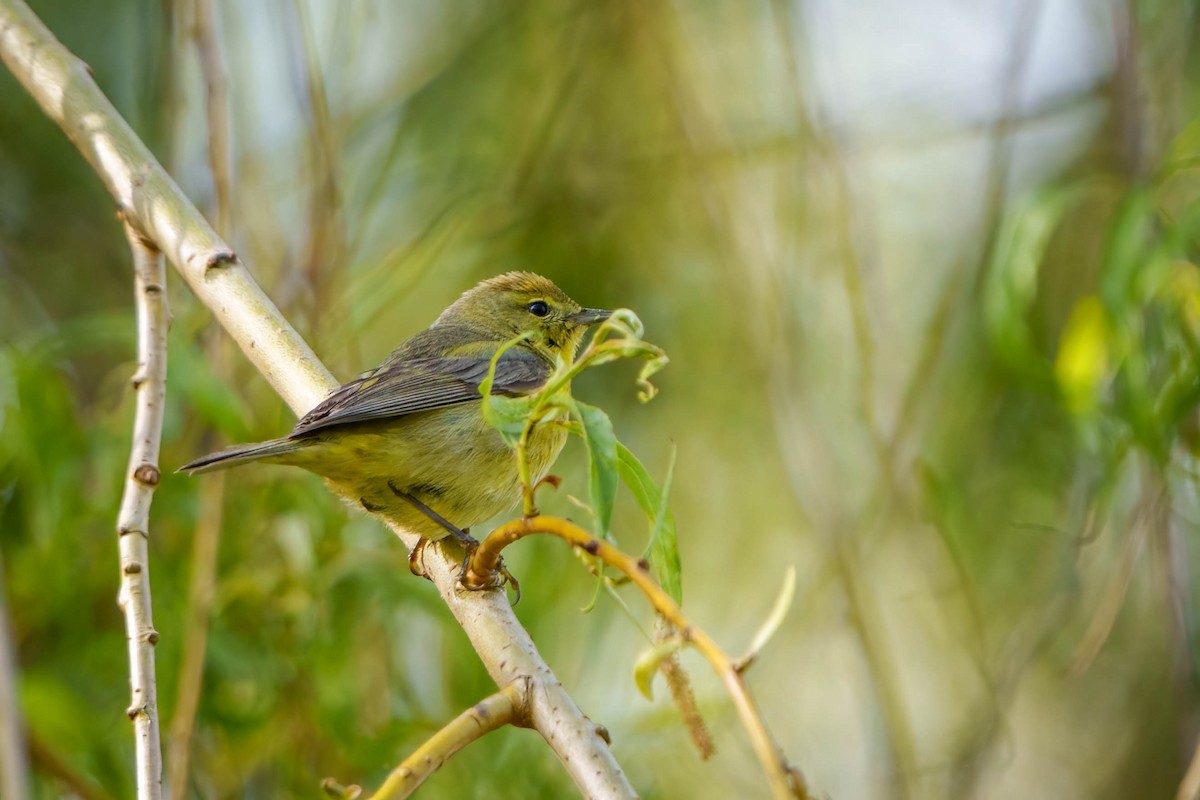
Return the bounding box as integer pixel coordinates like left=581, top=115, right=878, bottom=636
left=289, top=348, right=551, bottom=438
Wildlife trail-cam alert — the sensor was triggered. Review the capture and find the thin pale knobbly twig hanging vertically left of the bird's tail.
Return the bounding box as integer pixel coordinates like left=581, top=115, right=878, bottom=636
left=116, top=221, right=168, bottom=800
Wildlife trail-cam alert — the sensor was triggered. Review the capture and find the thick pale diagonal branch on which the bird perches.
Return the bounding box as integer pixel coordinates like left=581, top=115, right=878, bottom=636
left=0, top=7, right=635, bottom=798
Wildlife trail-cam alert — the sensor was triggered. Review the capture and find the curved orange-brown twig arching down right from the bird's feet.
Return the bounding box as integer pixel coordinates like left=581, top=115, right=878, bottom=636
left=462, top=516, right=809, bottom=798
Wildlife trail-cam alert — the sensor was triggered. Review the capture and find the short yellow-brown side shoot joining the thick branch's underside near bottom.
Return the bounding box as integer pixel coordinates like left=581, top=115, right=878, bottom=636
left=371, top=686, right=528, bottom=800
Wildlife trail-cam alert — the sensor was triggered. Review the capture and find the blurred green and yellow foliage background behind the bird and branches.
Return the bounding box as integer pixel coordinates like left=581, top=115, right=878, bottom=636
left=0, top=0, right=1200, bottom=799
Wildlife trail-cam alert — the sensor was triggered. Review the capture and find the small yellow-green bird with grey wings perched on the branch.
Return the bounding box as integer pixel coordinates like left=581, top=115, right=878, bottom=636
left=180, top=272, right=608, bottom=539
